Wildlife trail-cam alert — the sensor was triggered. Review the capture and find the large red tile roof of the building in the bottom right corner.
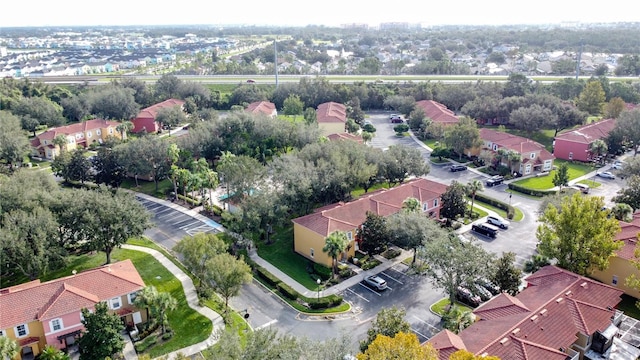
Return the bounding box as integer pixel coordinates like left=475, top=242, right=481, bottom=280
left=428, top=265, right=623, bottom=360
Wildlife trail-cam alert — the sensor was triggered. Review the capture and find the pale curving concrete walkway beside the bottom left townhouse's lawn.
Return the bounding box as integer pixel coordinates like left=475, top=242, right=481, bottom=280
left=122, top=244, right=224, bottom=360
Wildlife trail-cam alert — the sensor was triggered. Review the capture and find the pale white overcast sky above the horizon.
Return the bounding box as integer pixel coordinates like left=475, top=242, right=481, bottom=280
left=0, top=0, right=640, bottom=28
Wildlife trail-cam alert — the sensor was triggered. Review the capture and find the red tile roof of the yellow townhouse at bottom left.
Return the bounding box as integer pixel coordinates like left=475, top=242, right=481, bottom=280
left=0, top=260, right=144, bottom=329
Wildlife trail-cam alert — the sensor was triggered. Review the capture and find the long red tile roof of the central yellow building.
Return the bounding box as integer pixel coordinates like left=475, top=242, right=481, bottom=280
left=292, top=178, right=447, bottom=236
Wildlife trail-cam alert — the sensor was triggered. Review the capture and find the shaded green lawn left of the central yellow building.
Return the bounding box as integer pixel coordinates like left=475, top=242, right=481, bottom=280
left=256, top=225, right=317, bottom=290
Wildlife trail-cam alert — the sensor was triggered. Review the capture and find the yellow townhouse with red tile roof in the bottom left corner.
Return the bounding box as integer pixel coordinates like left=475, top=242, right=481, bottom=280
left=0, top=260, right=147, bottom=359
